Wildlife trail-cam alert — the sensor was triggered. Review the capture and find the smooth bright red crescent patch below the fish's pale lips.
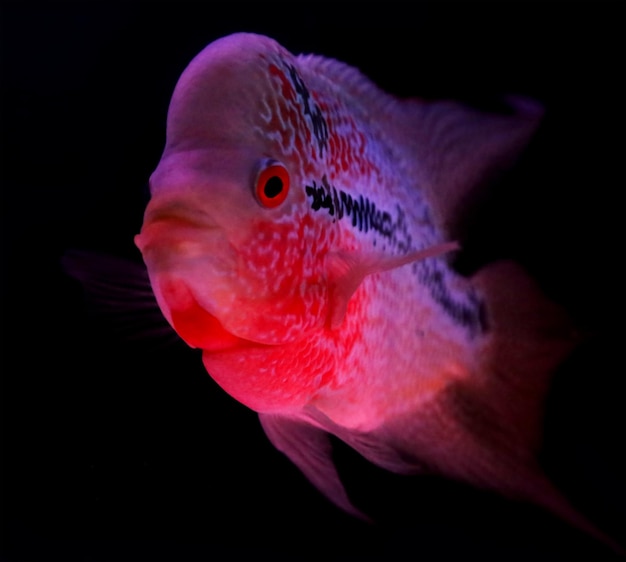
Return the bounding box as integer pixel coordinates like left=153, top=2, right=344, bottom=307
left=158, top=276, right=268, bottom=353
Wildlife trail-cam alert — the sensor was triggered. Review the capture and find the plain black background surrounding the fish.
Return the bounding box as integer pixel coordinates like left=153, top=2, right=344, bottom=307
left=0, top=1, right=626, bottom=561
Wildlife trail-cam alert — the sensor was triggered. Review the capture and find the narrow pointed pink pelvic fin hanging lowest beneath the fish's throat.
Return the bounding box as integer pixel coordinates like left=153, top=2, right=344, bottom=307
left=259, top=414, right=368, bottom=519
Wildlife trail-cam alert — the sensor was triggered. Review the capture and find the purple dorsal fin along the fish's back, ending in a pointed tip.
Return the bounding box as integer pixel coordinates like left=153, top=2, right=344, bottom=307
left=298, top=50, right=543, bottom=239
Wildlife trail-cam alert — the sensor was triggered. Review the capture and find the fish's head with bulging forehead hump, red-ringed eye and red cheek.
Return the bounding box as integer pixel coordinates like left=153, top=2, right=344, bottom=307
left=136, top=34, right=334, bottom=366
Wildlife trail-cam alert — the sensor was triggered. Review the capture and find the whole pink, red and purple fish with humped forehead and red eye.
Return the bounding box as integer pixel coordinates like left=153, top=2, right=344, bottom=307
left=136, top=34, right=616, bottom=544
